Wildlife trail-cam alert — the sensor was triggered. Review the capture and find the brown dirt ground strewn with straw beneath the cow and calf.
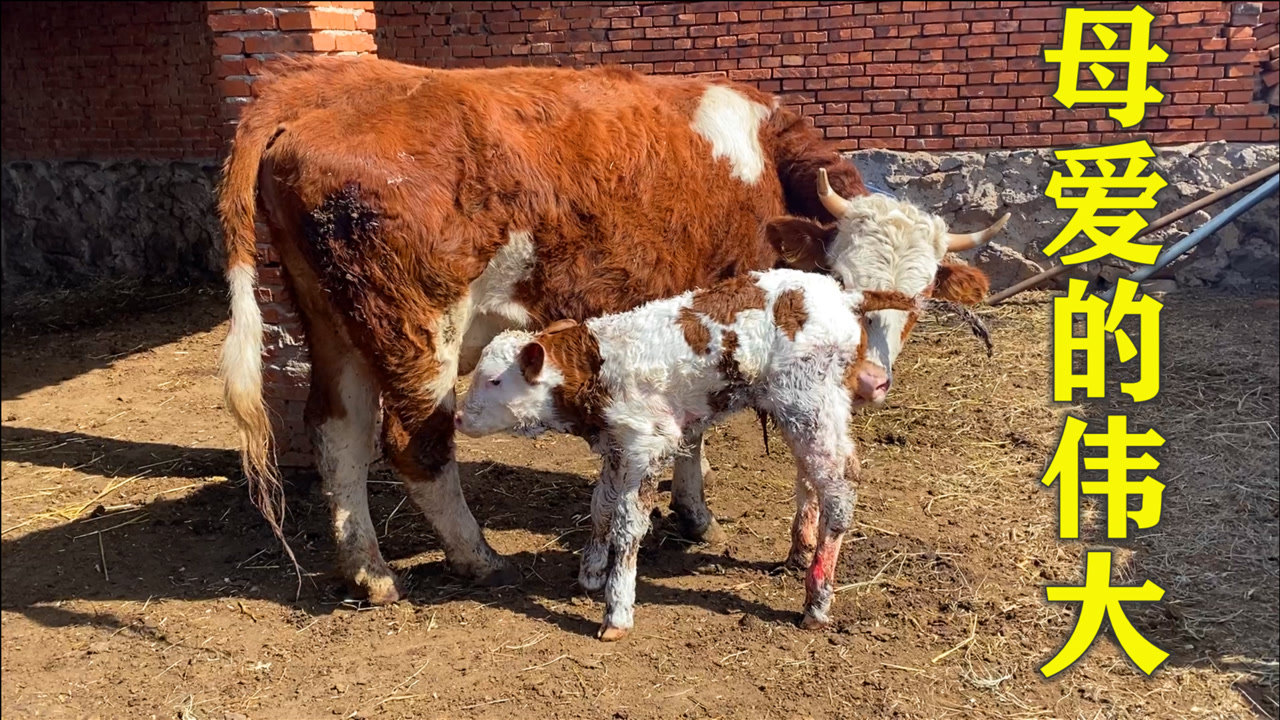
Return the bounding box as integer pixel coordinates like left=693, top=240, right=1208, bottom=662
left=3, top=281, right=1280, bottom=720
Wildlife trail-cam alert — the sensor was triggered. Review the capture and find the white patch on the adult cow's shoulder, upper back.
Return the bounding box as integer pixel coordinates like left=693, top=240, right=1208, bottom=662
left=691, top=85, right=769, bottom=183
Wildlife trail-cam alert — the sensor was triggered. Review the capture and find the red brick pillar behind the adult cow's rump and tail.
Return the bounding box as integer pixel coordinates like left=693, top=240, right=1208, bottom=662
left=207, top=3, right=378, bottom=466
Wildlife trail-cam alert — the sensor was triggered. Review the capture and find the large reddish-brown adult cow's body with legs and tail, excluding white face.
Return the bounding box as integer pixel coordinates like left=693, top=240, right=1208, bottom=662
left=219, top=58, right=1003, bottom=603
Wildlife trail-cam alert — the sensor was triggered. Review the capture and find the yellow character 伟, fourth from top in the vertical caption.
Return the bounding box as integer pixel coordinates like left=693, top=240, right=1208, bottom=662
left=1041, top=415, right=1165, bottom=539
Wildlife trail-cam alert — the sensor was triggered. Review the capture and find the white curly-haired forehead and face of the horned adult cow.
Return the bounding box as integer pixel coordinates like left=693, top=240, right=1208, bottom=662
left=827, top=195, right=947, bottom=380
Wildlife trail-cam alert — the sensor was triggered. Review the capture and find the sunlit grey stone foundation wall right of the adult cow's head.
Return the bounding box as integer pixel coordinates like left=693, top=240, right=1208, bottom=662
left=851, top=142, right=1280, bottom=290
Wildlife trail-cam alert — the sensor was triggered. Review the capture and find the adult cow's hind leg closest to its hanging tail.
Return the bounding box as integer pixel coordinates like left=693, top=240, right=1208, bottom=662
left=306, top=323, right=399, bottom=605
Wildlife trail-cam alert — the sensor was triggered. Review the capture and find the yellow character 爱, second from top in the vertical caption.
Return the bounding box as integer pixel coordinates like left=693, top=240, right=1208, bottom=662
left=1044, top=140, right=1169, bottom=265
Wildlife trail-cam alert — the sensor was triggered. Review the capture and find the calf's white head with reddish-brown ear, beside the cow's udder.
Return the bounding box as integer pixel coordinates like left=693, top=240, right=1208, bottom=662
left=454, top=331, right=563, bottom=437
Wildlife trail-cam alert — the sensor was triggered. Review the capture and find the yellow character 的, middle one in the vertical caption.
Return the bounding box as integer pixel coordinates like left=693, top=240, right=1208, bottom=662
left=1053, top=278, right=1165, bottom=402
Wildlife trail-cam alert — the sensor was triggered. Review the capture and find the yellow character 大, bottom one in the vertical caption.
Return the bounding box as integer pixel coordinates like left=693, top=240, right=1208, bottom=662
left=1041, top=551, right=1169, bottom=678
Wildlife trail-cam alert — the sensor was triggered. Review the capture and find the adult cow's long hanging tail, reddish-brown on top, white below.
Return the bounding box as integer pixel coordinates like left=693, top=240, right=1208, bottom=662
left=218, top=117, right=302, bottom=591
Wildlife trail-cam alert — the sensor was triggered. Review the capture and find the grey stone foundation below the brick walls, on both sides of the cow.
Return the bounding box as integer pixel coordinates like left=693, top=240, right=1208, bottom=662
left=0, top=142, right=1280, bottom=293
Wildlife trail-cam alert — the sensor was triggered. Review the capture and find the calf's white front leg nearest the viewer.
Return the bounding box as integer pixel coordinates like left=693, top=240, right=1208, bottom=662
left=598, top=461, right=657, bottom=642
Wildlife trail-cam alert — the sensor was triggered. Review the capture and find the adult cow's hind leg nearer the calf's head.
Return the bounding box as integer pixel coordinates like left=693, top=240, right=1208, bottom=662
left=383, top=389, right=520, bottom=585
